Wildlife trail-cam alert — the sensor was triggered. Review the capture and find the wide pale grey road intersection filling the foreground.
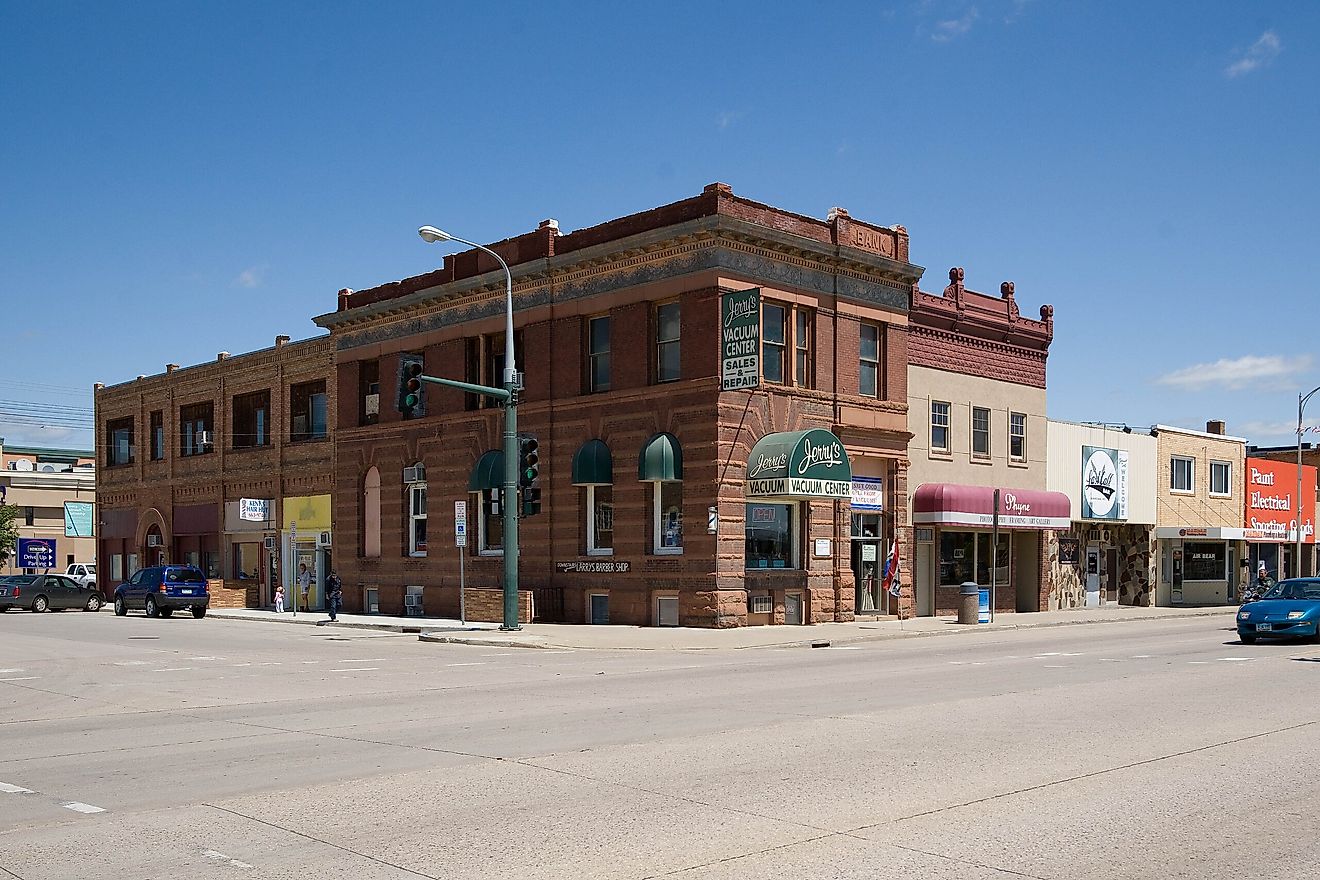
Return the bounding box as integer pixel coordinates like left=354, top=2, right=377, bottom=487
left=0, top=612, right=1320, bottom=880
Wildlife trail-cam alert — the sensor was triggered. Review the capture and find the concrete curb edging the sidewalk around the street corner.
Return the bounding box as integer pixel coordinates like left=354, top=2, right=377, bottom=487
left=418, top=608, right=1237, bottom=650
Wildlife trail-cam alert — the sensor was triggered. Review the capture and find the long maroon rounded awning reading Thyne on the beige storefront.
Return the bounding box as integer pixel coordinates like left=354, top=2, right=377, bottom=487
left=912, top=483, right=1072, bottom=529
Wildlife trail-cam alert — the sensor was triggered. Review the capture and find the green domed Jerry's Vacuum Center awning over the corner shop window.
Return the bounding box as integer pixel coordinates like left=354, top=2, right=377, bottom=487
left=747, top=427, right=853, bottom=499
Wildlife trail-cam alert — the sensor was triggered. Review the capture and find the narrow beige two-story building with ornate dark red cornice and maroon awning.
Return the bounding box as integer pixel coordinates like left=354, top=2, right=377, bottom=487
left=900, top=268, right=1068, bottom=616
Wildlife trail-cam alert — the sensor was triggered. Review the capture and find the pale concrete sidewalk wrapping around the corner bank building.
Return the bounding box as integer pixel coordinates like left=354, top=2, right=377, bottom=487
left=207, top=606, right=1237, bottom=650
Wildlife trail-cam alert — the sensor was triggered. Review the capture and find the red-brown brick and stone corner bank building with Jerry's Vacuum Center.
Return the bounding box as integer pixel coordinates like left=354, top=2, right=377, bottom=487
left=315, top=183, right=921, bottom=627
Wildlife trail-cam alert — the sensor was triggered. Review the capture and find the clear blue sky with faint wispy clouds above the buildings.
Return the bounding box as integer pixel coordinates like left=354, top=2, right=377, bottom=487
left=0, top=0, right=1320, bottom=446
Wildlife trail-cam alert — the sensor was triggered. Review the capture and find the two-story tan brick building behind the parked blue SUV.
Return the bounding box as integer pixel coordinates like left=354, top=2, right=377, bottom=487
left=95, top=336, right=337, bottom=607
